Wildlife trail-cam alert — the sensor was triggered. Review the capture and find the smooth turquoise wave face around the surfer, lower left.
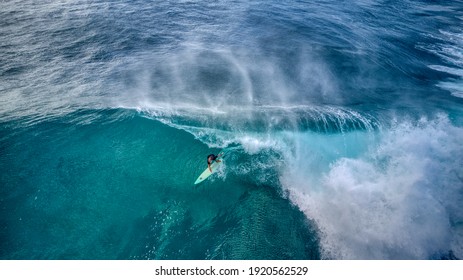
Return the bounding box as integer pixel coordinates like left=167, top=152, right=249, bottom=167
left=1, top=110, right=319, bottom=259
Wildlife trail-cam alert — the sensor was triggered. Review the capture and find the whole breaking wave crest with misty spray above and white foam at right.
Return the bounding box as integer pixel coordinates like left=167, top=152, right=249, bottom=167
left=115, top=40, right=463, bottom=259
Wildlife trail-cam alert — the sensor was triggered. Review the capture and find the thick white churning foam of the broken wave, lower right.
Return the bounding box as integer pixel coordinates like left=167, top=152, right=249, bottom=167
left=281, top=116, right=463, bottom=259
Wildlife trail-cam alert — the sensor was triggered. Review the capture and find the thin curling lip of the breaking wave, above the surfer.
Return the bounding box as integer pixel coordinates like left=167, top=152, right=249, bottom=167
left=136, top=104, right=379, bottom=136
